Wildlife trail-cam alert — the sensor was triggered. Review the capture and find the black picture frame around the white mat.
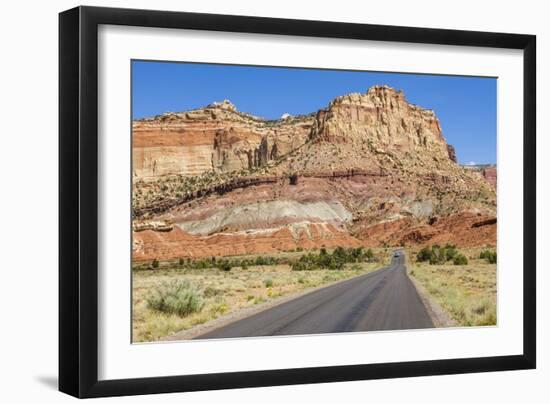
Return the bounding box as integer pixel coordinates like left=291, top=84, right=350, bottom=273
left=59, top=7, right=536, bottom=398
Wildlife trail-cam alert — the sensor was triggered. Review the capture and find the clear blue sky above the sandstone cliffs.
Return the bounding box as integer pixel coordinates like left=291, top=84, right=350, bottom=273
left=132, top=61, right=497, bottom=164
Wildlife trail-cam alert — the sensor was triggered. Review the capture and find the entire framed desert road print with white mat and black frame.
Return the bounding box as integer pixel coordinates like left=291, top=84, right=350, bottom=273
left=59, top=7, right=536, bottom=397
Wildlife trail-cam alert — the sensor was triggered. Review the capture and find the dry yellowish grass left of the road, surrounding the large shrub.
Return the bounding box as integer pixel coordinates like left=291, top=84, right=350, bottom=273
left=132, top=263, right=382, bottom=342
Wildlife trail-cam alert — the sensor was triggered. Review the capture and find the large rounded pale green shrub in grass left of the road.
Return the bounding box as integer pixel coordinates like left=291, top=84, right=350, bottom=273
left=147, top=280, right=204, bottom=317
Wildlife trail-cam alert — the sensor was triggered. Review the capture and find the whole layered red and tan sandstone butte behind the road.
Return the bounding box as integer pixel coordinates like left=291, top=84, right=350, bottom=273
left=132, top=86, right=497, bottom=261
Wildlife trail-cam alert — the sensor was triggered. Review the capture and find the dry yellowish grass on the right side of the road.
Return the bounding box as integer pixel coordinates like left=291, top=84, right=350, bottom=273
left=408, top=249, right=497, bottom=326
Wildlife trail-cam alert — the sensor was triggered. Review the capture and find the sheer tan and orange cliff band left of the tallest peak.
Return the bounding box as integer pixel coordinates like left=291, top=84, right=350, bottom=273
left=133, top=100, right=314, bottom=180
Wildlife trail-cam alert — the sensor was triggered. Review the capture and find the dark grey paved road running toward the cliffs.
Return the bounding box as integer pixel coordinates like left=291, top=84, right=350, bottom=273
left=198, top=255, right=434, bottom=338
